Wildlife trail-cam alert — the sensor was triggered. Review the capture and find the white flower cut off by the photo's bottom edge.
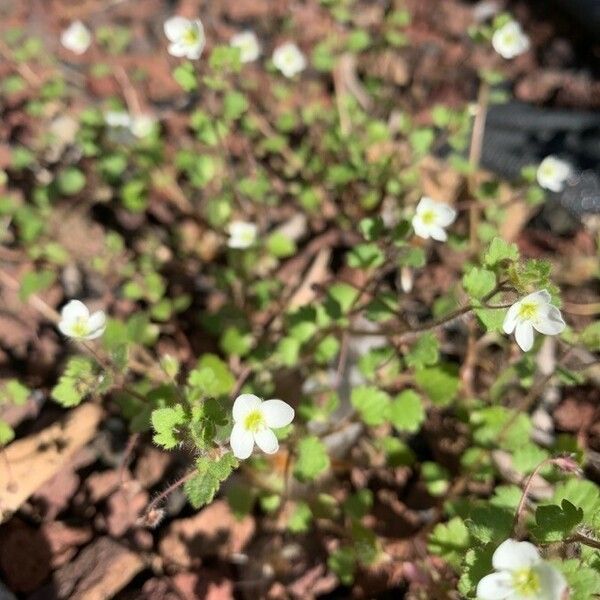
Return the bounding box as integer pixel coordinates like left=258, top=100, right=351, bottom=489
left=477, top=539, right=567, bottom=600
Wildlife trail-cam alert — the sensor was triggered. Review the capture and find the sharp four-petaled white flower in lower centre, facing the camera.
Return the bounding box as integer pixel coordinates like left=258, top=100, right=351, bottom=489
left=229, top=394, right=294, bottom=459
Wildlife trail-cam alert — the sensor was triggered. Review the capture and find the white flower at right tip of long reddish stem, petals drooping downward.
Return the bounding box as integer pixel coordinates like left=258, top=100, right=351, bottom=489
left=502, top=290, right=566, bottom=352
